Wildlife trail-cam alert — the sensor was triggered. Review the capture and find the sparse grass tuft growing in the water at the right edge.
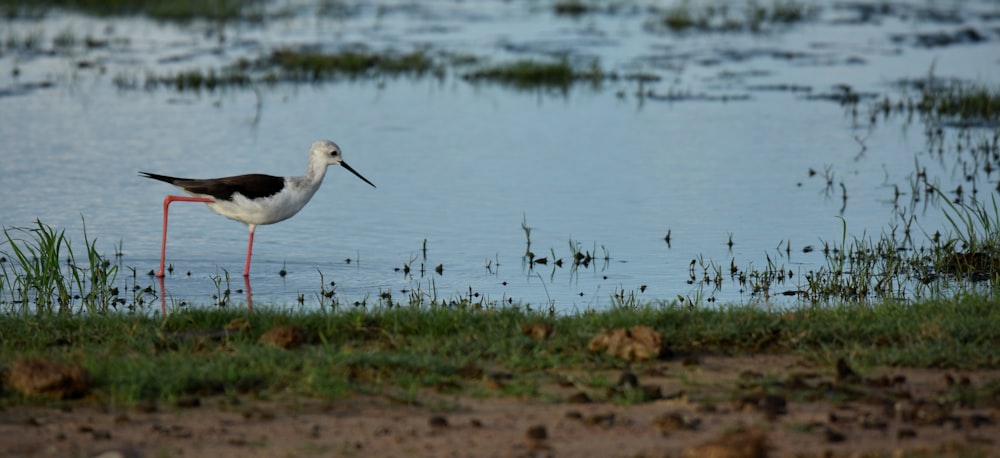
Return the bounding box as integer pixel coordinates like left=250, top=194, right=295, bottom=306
left=689, top=190, right=1000, bottom=305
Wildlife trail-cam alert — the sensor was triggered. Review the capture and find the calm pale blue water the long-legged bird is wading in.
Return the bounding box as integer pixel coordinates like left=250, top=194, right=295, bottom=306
left=0, top=2, right=1000, bottom=311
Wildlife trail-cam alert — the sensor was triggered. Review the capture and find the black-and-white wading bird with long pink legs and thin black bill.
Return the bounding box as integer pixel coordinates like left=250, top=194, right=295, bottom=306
left=139, top=140, right=375, bottom=278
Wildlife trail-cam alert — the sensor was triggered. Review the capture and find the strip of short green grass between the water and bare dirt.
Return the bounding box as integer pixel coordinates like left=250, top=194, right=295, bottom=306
left=0, top=297, right=1000, bottom=405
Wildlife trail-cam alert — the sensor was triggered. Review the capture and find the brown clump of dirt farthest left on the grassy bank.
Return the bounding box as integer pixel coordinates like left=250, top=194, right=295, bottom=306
left=7, top=358, right=92, bottom=399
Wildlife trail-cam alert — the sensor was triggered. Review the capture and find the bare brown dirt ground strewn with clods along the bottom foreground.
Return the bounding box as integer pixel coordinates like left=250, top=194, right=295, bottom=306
left=0, top=355, right=1000, bottom=458
